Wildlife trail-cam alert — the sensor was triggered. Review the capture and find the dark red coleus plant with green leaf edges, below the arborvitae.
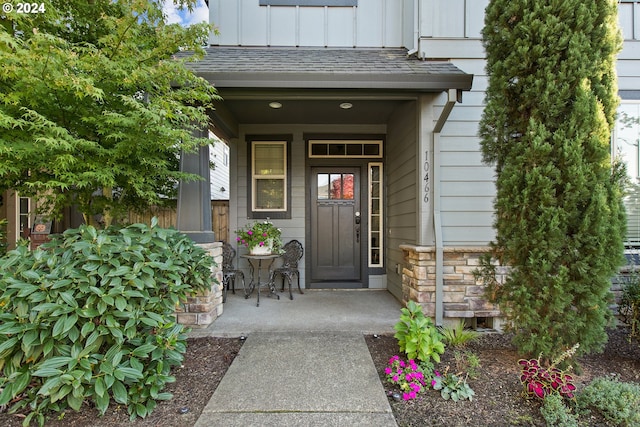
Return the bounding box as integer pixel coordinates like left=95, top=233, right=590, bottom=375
left=518, top=344, right=578, bottom=399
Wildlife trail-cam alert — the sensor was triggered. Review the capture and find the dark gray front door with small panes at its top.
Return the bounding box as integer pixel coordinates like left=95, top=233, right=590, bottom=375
left=311, top=167, right=363, bottom=287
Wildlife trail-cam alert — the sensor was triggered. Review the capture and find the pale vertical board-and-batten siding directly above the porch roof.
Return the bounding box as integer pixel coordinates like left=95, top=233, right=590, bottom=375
left=209, top=0, right=414, bottom=47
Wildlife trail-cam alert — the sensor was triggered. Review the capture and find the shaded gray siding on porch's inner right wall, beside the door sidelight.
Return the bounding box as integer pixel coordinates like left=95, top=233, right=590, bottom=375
left=385, top=102, right=420, bottom=300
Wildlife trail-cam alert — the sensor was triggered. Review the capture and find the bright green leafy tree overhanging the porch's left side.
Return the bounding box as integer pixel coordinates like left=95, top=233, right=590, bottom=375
left=0, top=0, right=216, bottom=226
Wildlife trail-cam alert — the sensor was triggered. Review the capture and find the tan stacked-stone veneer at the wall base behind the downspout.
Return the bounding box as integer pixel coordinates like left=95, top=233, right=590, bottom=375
left=400, top=245, right=506, bottom=318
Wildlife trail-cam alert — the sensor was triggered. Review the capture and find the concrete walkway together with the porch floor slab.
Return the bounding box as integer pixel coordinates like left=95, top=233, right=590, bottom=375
left=191, top=290, right=401, bottom=427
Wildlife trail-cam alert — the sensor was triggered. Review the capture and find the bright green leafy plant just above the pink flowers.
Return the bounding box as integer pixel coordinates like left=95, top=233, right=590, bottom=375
left=394, top=301, right=444, bottom=364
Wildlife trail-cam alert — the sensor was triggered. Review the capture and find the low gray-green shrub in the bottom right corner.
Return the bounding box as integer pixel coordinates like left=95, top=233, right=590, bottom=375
left=576, top=377, right=640, bottom=427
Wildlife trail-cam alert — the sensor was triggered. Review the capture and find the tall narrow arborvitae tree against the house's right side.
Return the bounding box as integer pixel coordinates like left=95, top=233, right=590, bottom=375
left=480, top=0, right=625, bottom=357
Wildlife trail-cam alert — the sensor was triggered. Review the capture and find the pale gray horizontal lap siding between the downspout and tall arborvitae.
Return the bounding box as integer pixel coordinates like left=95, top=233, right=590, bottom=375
left=422, top=32, right=495, bottom=246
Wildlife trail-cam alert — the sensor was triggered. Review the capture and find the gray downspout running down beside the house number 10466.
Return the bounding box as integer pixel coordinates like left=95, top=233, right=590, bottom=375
left=433, top=89, right=462, bottom=326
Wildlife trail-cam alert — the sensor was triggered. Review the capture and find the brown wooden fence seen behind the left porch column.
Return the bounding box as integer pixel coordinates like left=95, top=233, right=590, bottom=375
left=127, top=200, right=229, bottom=242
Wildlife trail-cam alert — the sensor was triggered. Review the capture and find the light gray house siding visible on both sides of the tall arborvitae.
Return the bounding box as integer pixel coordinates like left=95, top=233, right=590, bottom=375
left=420, top=0, right=640, bottom=246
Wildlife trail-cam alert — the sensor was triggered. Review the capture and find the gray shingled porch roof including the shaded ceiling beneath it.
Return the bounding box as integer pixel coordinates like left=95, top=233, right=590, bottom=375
left=184, top=46, right=473, bottom=136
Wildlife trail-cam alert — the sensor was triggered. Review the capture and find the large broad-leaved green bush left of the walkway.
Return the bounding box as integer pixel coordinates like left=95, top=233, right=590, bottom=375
left=0, top=221, right=212, bottom=425
